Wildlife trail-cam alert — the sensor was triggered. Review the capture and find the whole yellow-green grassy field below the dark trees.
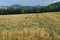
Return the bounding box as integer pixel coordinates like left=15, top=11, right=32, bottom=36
left=0, top=12, right=60, bottom=40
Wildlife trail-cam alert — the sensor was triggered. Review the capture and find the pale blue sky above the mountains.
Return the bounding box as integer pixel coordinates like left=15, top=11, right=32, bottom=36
left=0, top=0, right=60, bottom=6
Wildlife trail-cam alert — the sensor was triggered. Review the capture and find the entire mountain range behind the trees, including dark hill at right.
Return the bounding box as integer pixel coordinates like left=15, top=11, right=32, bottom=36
left=0, top=1, right=60, bottom=9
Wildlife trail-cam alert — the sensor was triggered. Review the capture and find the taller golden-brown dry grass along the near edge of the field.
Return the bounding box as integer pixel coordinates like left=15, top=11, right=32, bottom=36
left=0, top=28, right=60, bottom=40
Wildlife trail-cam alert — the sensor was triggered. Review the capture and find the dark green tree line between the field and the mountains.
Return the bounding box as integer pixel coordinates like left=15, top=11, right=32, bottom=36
left=0, top=6, right=60, bottom=15
